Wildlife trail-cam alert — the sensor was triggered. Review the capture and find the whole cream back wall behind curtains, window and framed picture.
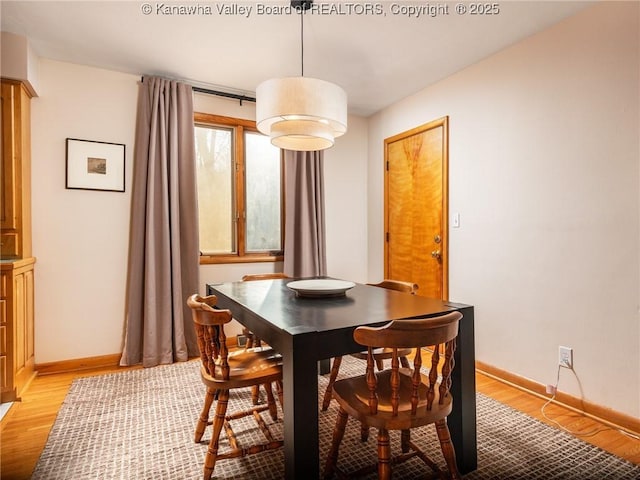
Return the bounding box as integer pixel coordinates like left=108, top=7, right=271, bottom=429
left=32, top=66, right=367, bottom=363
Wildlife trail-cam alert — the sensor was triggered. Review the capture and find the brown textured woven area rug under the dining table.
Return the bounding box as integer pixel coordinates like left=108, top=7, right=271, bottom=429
left=32, top=357, right=640, bottom=480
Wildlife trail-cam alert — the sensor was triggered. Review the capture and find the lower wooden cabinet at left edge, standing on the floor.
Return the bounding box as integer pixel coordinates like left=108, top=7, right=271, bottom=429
left=0, top=258, right=35, bottom=402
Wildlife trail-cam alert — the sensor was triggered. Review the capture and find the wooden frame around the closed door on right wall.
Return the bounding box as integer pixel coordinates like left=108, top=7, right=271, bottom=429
left=383, top=116, right=449, bottom=300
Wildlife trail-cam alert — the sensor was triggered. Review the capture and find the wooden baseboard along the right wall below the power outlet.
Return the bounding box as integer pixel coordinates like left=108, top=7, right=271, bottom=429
left=476, top=362, right=640, bottom=435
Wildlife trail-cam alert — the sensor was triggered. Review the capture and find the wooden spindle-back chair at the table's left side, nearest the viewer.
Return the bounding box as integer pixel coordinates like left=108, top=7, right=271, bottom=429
left=187, top=294, right=283, bottom=480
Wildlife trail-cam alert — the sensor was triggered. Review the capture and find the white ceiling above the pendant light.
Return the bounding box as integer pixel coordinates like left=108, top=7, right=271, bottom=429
left=0, top=0, right=590, bottom=116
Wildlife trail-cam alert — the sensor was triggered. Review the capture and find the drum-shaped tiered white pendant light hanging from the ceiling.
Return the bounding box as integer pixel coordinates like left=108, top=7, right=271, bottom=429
left=256, top=0, right=347, bottom=151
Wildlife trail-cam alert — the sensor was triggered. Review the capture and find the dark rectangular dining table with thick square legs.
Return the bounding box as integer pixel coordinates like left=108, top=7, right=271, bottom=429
left=207, top=279, right=477, bottom=480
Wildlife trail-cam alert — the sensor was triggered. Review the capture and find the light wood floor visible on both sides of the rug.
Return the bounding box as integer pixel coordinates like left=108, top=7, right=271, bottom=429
left=0, top=367, right=640, bottom=480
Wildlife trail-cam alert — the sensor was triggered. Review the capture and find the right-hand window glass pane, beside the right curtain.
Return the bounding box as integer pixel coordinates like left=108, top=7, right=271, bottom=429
left=245, top=132, right=282, bottom=252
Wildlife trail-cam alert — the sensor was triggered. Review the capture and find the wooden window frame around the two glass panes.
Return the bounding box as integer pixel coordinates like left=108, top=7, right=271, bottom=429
left=194, top=112, right=285, bottom=265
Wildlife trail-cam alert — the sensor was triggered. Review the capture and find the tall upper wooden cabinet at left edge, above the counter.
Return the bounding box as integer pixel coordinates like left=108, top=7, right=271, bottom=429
left=0, top=79, right=32, bottom=259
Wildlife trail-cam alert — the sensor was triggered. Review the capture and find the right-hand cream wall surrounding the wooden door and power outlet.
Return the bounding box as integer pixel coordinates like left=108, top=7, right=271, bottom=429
left=368, top=2, right=640, bottom=417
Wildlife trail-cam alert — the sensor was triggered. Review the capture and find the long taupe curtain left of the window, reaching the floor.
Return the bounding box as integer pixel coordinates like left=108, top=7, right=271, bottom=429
left=120, top=77, right=199, bottom=367
